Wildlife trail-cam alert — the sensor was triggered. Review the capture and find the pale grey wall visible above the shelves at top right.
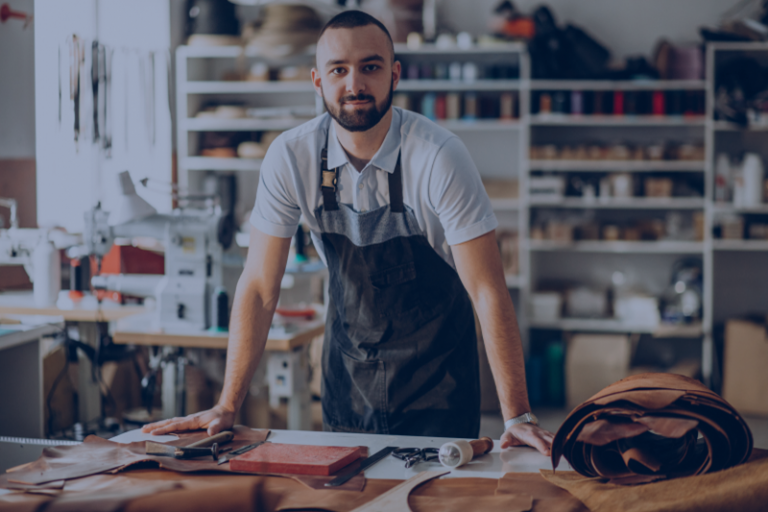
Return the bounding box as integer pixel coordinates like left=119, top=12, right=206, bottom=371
left=438, top=0, right=741, bottom=59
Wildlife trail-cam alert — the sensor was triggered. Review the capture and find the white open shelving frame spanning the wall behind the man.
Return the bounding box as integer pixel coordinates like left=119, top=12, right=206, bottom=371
left=176, top=43, right=768, bottom=388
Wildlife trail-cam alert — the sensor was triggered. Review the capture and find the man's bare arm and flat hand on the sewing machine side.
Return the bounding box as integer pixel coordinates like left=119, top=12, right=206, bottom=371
left=142, top=227, right=291, bottom=435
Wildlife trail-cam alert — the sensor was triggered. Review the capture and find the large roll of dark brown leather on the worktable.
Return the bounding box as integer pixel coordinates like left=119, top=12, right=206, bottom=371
left=552, top=373, right=752, bottom=484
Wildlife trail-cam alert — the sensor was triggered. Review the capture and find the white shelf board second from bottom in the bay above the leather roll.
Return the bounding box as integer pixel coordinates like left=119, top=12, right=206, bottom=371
left=529, top=240, right=704, bottom=254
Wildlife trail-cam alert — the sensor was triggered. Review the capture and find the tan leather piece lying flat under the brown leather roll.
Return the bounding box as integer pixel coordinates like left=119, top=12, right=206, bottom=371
left=541, top=448, right=768, bottom=512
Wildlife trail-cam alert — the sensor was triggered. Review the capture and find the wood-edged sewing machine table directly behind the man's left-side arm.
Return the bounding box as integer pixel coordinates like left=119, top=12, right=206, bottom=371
left=112, top=314, right=325, bottom=430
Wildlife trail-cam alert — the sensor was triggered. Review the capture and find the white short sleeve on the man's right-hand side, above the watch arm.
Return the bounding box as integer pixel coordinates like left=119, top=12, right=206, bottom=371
left=429, top=137, right=499, bottom=245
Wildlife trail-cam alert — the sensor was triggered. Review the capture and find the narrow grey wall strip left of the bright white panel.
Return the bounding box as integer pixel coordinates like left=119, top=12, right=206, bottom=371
left=0, top=0, right=35, bottom=158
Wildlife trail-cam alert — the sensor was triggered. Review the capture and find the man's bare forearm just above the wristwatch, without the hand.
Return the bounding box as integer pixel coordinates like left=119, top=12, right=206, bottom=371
left=475, top=281, right=531, bottom=420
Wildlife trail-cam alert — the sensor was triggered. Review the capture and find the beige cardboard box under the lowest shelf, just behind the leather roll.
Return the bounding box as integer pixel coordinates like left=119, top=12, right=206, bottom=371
left=565, top=334, right=632, bottom=409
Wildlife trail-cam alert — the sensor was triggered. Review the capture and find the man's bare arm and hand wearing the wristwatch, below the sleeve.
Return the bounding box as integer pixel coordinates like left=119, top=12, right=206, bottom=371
left=451, top=231, right=553, bottom=455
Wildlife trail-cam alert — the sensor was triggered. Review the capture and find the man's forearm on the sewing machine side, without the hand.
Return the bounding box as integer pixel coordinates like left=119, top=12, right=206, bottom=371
left=219, top=276, right=279, bottom=412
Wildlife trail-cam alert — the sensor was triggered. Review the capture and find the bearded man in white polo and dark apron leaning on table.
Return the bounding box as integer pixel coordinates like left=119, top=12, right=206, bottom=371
left=144, top=11, right=552, bottom=454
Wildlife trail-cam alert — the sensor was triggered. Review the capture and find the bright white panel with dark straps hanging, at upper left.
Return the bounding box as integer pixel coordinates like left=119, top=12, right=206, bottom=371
left=34, top=0, right=171, bottom=232
